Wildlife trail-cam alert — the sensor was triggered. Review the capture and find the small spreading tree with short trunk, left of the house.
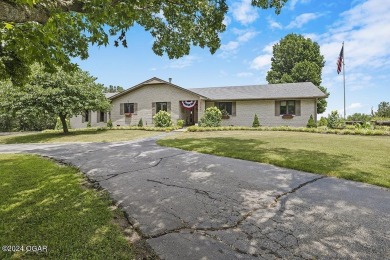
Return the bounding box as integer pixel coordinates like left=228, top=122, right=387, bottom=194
left=11, top=64, right=110, bottom=133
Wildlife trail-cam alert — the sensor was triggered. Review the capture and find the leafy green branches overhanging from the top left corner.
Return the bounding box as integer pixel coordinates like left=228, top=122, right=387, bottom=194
left=0, top=0, right=287, bottom=82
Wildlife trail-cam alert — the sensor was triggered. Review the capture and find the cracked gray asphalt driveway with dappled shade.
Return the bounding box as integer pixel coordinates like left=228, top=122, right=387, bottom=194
left=0, top=134, right=390, bottom=259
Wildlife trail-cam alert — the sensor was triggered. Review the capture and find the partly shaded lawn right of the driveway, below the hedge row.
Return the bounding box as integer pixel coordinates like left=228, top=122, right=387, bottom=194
left=158, top=131, right=390, bottom=188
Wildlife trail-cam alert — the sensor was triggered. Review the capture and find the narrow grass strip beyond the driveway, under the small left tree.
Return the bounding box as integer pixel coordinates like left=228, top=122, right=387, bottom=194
left=0, top=130, right=160, bottom=144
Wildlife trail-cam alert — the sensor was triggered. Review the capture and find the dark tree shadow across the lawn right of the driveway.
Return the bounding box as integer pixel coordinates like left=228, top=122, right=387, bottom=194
left=158, top=137, right=353, bottom=179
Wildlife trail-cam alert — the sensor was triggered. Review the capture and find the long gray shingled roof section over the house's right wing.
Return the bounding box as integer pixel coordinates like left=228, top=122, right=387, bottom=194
left=189, top=82, right=326, bottom=100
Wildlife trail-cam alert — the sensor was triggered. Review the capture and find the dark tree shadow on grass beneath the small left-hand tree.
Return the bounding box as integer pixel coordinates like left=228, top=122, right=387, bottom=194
left=0, top=130, right=107, bottom=144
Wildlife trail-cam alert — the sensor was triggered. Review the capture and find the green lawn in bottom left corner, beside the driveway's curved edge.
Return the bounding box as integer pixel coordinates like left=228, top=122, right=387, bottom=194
left=0, top=154, right=134, bottom=259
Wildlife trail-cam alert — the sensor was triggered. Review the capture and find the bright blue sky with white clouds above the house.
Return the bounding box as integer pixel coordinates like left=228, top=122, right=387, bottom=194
left=74, top=0, right=390, bottom=115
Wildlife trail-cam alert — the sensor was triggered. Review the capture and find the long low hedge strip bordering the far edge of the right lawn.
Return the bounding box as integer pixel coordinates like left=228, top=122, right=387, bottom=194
left=187, top=126, right=390, bottom=136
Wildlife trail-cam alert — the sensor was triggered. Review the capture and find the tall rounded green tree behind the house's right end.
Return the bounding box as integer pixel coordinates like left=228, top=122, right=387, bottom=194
left=266, top=34, right=329, bottom=114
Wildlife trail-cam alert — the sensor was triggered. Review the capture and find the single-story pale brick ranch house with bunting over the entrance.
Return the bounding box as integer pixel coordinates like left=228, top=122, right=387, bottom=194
left=70, top=77, right=326, bottom=128
